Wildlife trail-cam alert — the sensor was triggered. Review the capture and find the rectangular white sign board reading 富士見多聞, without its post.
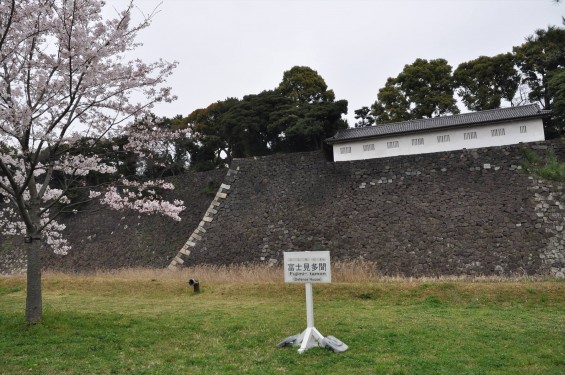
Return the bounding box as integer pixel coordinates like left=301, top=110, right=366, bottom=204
left=284, top=251, right=332, bottom=283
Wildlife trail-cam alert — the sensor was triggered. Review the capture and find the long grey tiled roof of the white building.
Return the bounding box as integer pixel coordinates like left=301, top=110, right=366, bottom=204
left=326, top=104, right=551, bottom=144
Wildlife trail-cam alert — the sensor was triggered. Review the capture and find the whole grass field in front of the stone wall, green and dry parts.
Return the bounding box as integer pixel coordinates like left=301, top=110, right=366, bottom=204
left=0, top=268, right=565, bottom=374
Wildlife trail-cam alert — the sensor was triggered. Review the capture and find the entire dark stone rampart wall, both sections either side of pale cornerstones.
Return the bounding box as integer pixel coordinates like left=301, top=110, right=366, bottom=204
left=4, top=142, right=565, bottom=277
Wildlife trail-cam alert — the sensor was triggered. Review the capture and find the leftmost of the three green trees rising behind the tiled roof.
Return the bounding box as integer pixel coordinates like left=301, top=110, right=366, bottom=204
left=372, top=59, right=459, bottom=124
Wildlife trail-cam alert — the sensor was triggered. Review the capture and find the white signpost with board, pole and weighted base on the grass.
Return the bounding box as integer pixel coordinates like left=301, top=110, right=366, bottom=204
left=277, top=251, right=348, bottom=353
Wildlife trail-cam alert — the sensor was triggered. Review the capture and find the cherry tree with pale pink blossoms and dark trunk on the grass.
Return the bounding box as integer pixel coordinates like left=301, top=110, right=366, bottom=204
left=0, top=0, right=184, bottom=324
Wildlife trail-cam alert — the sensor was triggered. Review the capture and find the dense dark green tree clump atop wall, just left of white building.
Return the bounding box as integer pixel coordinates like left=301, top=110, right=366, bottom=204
left=186, top=66, right=347, bottom=164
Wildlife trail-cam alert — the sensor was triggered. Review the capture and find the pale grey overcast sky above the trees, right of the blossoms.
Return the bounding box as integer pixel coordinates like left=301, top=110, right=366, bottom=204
left=106, top=0, right=565, bottom=126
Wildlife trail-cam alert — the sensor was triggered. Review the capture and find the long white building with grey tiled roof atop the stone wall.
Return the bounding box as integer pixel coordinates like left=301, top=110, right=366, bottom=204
left=326, top=104, right=551, bottom=161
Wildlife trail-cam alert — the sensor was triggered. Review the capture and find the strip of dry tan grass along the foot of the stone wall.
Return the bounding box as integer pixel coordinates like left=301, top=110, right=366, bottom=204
left=0, top=260, right=565, bottom=311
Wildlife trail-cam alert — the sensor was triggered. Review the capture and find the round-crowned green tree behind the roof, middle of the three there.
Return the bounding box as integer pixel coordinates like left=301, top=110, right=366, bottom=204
left=453, top=53, right=520, bottom=111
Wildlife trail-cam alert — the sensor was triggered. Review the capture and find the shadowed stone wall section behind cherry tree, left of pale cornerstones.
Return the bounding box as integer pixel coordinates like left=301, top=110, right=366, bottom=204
left=0, top=169, right=227, bottom=274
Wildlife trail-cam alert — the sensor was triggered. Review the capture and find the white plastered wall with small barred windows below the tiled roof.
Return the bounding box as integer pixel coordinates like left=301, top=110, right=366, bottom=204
left=333, top=118, right=545, bottom=161
